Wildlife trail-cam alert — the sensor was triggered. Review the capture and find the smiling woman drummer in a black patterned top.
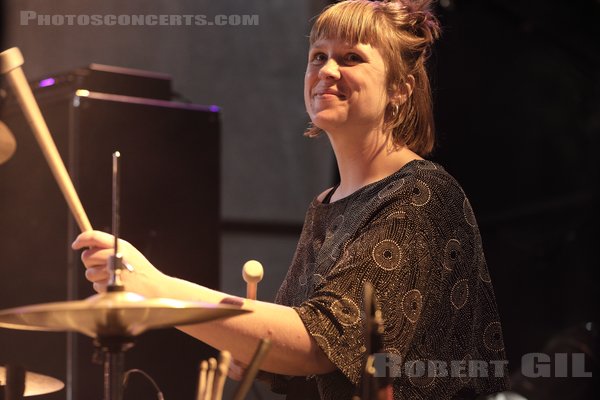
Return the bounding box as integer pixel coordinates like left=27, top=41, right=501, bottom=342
left=73, top=0, right=507, bottom=399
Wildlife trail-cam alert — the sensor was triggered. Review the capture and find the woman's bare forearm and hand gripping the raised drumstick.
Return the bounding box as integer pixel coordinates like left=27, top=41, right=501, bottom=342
left=72, top=231, right=335, bottom=375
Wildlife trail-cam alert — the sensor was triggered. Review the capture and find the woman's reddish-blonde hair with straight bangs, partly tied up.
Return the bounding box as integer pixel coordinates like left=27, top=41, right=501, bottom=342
left=305, top=0, right=440, bottom=156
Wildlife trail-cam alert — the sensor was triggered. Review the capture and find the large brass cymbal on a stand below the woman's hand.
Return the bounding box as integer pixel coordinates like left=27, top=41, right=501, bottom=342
left=0, top=291, right=249, bottom=338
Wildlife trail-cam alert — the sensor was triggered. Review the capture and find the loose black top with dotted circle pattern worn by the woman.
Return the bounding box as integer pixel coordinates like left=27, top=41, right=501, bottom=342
left=272, top=160, right=508, bottom=399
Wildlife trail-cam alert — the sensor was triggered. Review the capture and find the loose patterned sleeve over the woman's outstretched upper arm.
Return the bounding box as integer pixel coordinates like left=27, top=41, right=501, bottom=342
left=296, top=193, right=433, bottom=385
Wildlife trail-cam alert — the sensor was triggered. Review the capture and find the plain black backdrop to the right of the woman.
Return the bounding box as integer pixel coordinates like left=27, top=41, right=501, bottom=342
left=431, top=1, right=600, bottom=399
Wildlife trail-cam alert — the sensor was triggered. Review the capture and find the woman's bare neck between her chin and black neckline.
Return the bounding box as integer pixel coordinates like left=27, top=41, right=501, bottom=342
left=328, top=128, right=421, bottom=201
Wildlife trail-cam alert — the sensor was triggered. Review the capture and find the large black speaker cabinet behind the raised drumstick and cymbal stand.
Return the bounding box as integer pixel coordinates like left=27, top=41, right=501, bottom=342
left=0, top=89, right=220, bottom=400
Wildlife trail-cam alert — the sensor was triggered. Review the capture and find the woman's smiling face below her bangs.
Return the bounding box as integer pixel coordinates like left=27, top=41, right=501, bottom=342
left=304, top=39, right=389, bottom=133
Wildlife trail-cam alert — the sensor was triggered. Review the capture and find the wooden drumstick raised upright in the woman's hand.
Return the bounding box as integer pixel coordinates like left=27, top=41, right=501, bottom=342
left=0, top=47, right=92, bottom=232
